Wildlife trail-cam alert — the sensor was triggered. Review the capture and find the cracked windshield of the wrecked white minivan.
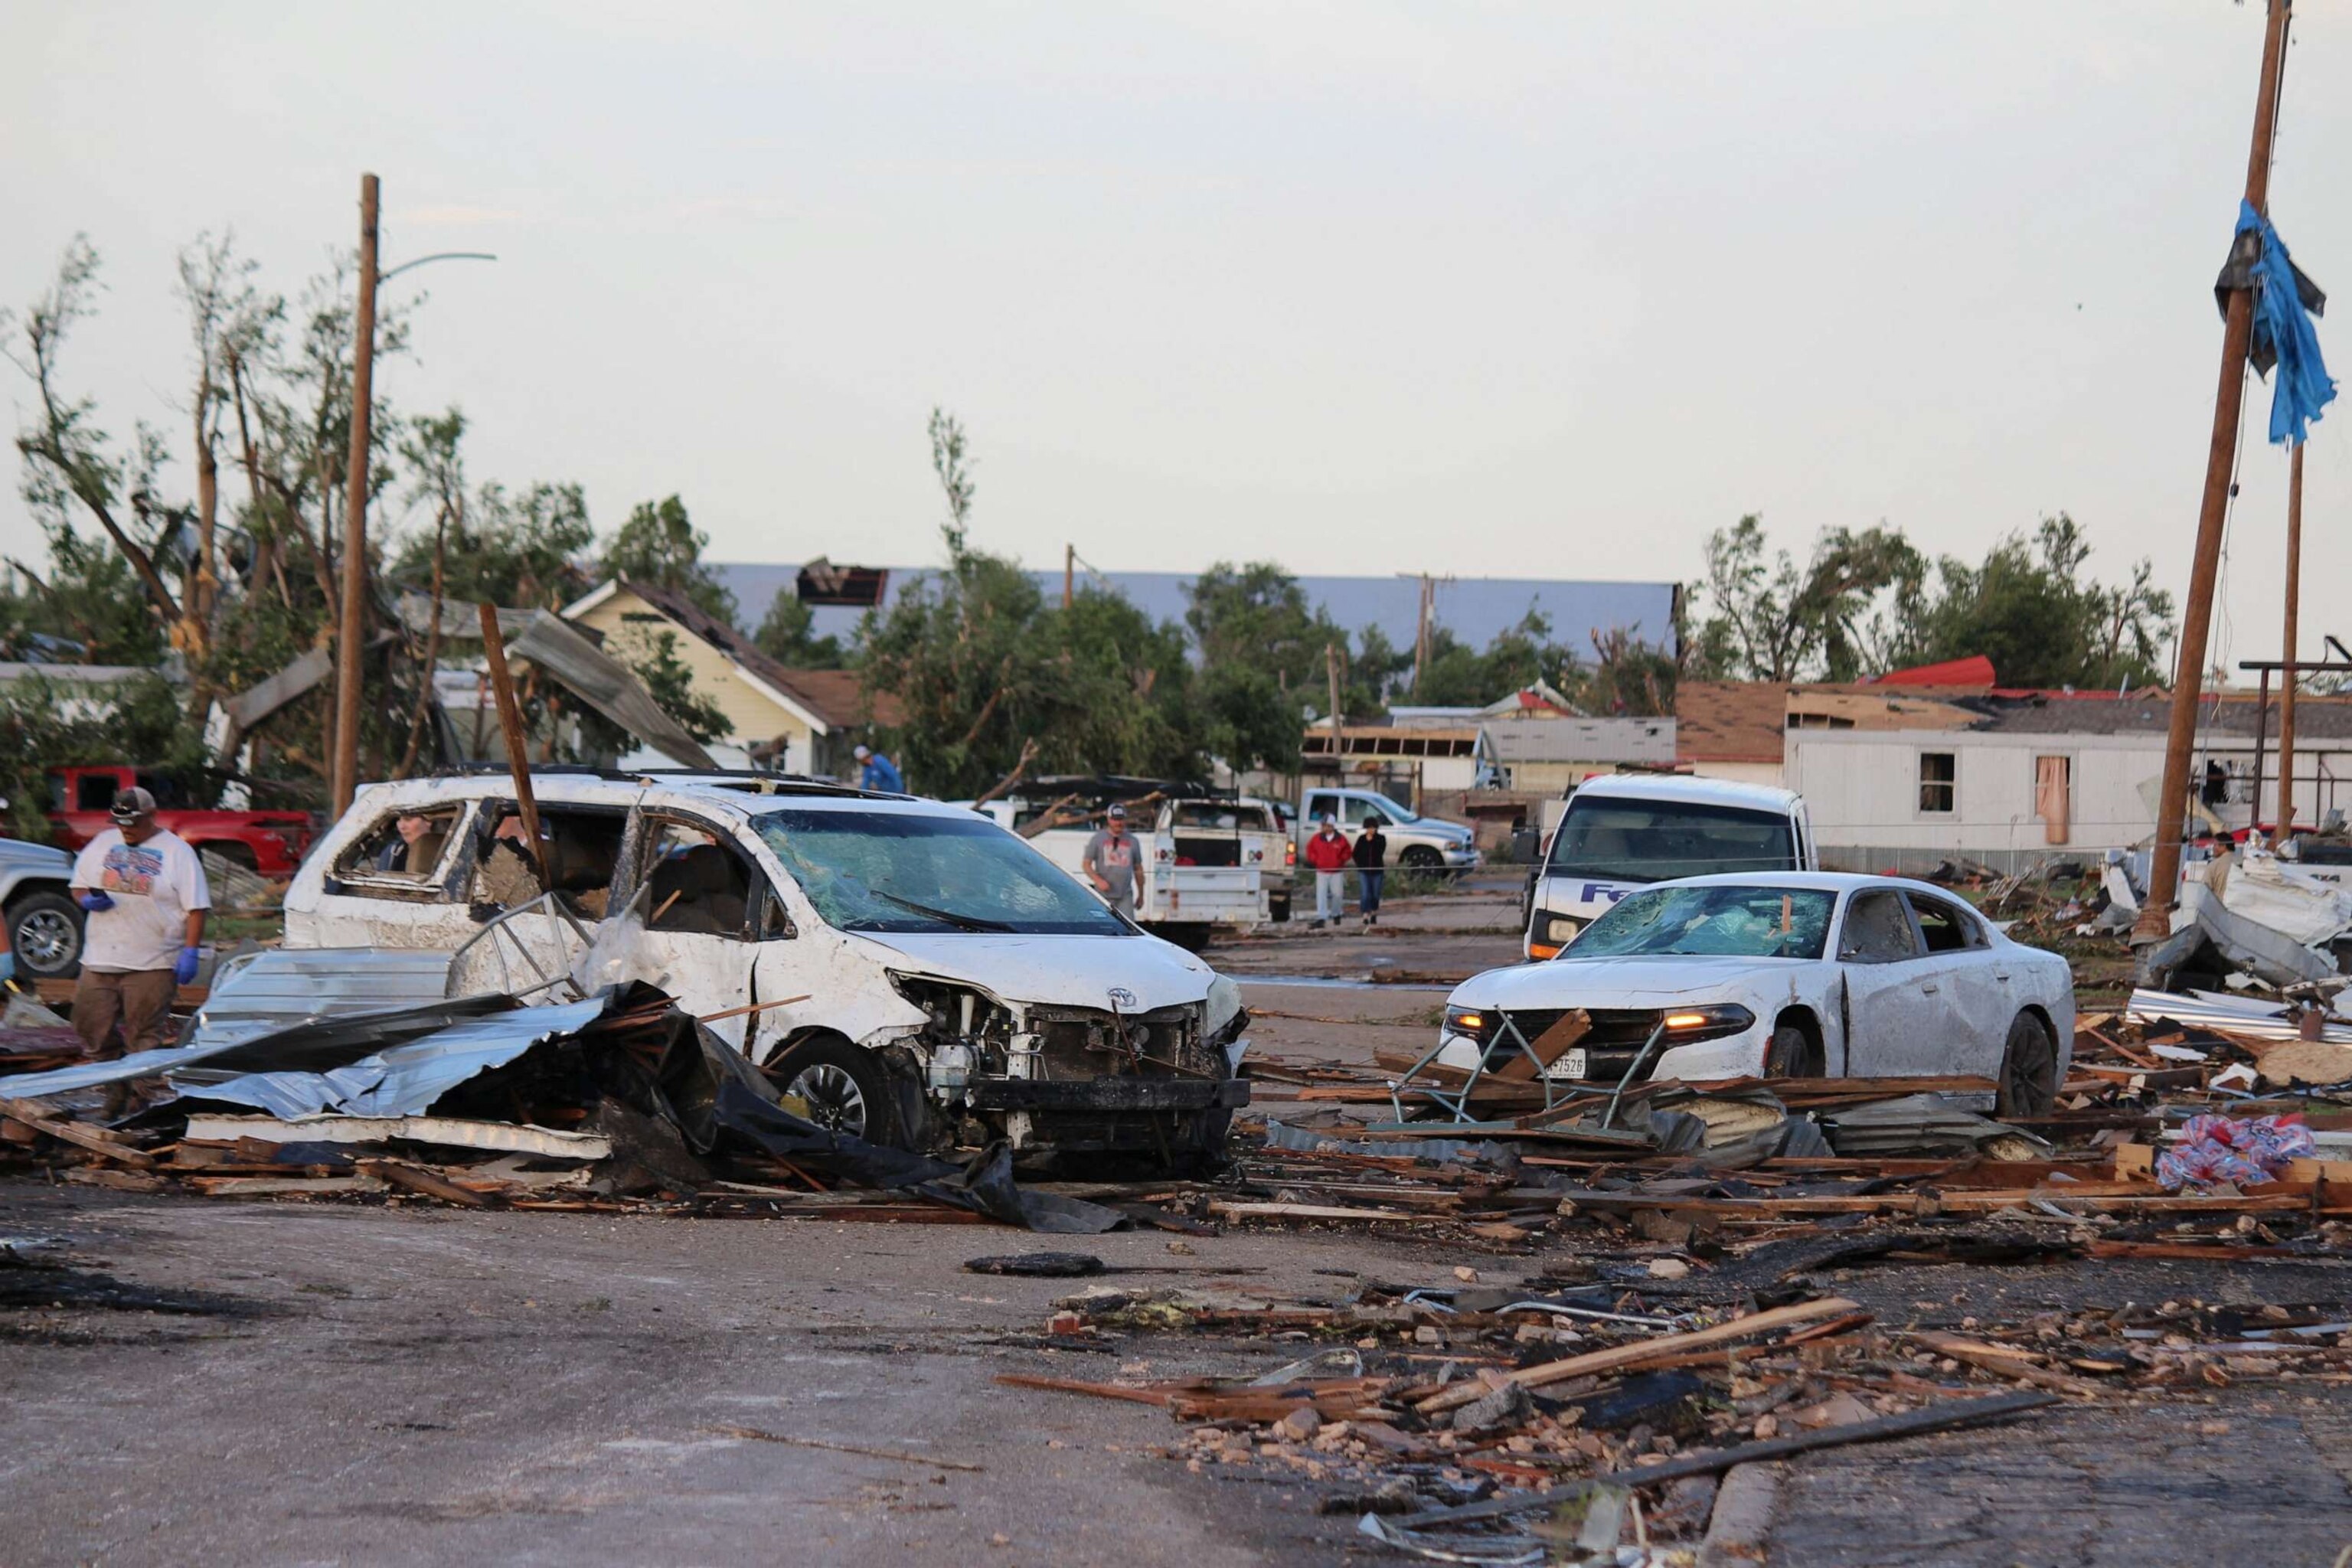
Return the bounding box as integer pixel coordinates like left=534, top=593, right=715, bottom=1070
left=757, top=808, right=1129, bottom=936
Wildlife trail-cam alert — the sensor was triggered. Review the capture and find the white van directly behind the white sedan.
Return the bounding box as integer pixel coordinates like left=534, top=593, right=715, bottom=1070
left=1524, top=773, right=1821, bottom=959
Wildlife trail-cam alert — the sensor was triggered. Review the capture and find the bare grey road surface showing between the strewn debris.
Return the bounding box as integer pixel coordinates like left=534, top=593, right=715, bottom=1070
left=0, top=877, right=2352, bottom=1568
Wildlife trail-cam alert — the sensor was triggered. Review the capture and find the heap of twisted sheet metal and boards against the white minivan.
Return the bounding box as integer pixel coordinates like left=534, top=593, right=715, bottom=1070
left=0, top=982, right=1126, bottom=1232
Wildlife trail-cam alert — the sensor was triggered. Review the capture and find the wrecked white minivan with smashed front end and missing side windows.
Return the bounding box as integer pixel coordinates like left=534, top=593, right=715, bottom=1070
left=285, top=769, right=1249, bottom=1166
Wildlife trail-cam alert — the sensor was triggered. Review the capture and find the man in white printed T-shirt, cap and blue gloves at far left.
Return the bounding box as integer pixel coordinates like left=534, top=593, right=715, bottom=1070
left=73, top=788, right=211, bottom=1114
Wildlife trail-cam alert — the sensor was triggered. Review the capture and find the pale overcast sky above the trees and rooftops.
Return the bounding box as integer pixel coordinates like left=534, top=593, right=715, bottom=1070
left=0, top=0, right=2352, bottom=677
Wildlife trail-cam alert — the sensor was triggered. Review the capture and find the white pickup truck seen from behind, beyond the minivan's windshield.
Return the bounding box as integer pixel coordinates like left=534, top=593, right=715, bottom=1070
left=978, top=778, right=1292, bottom=952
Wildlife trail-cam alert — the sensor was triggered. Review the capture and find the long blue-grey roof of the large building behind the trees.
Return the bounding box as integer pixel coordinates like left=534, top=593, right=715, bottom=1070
left=710, top=562, right=1674, bottom=656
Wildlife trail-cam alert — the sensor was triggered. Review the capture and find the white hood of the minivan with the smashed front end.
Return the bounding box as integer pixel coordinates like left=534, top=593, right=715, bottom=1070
left=851, top=931, right=1216, bottom=1013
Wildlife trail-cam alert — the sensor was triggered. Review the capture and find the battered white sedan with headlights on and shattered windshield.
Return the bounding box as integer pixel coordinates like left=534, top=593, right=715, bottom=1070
left=1437, top=872, right=2075, bottom=1116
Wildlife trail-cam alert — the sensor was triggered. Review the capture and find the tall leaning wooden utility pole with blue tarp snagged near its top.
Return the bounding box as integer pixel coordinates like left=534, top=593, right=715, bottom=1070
left=2133, top=0, right=2291, bottom=940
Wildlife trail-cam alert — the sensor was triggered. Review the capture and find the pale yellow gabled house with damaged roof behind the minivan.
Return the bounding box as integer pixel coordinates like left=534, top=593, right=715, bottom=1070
left=564, top=578, right=903, bottom=778
